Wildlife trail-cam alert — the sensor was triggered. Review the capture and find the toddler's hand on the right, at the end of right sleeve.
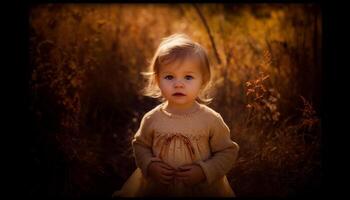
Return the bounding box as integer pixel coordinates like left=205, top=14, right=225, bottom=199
left=175, top=164, right=206, bottom=186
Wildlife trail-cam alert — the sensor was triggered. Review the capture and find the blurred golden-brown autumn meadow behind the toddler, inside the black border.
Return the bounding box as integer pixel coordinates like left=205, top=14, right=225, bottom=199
left=27, top=4, right=322, bottom=198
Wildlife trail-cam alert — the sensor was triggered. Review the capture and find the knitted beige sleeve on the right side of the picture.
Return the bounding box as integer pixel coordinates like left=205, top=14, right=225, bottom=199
left=198, top=113, right=239, bottom=184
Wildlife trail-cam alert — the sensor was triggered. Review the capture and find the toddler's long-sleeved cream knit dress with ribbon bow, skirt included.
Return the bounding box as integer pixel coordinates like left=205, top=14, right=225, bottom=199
left=116, top=103, right=239, bottom=196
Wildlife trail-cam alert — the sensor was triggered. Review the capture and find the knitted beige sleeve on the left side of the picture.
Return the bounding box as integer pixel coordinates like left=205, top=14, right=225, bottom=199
left=132, top=114, right=160, bottom=177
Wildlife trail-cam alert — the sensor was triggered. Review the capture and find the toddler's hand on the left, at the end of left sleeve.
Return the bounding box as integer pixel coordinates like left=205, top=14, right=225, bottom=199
left=148, top=161, right=175, bottom=185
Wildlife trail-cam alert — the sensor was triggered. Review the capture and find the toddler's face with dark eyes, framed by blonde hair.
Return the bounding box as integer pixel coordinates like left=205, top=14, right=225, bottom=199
left=158, top=58, right=203, bottom=105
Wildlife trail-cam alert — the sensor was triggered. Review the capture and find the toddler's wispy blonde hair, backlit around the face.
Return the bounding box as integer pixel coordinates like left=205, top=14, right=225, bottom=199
left=141, top=33, right=213, bottom=104
